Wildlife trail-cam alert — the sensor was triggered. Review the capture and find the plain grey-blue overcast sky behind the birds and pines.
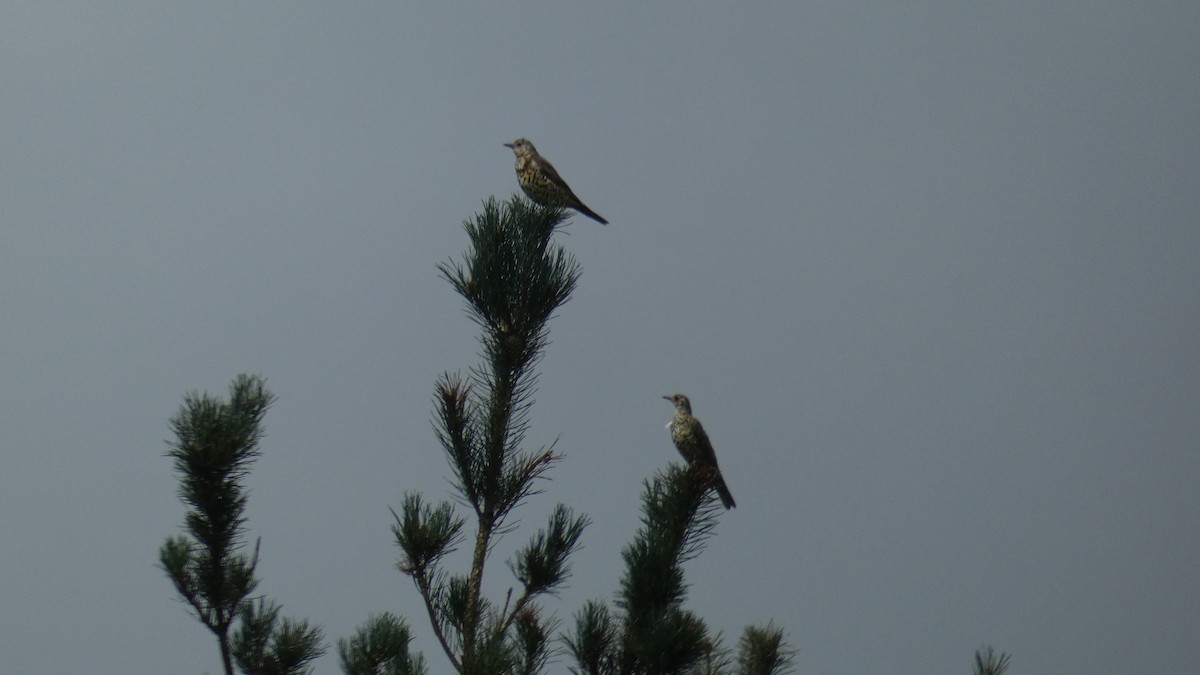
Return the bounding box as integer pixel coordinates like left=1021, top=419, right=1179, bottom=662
left=0, top=0, right=1200, bottom=675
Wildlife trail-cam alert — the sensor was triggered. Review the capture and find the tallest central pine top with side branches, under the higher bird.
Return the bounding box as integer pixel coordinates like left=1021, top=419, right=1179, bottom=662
left=392, top=197, right=588, bottom=675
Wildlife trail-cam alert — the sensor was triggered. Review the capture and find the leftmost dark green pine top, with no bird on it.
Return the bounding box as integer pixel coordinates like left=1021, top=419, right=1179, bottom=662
left=158, top=375, right=324, bottom=675
